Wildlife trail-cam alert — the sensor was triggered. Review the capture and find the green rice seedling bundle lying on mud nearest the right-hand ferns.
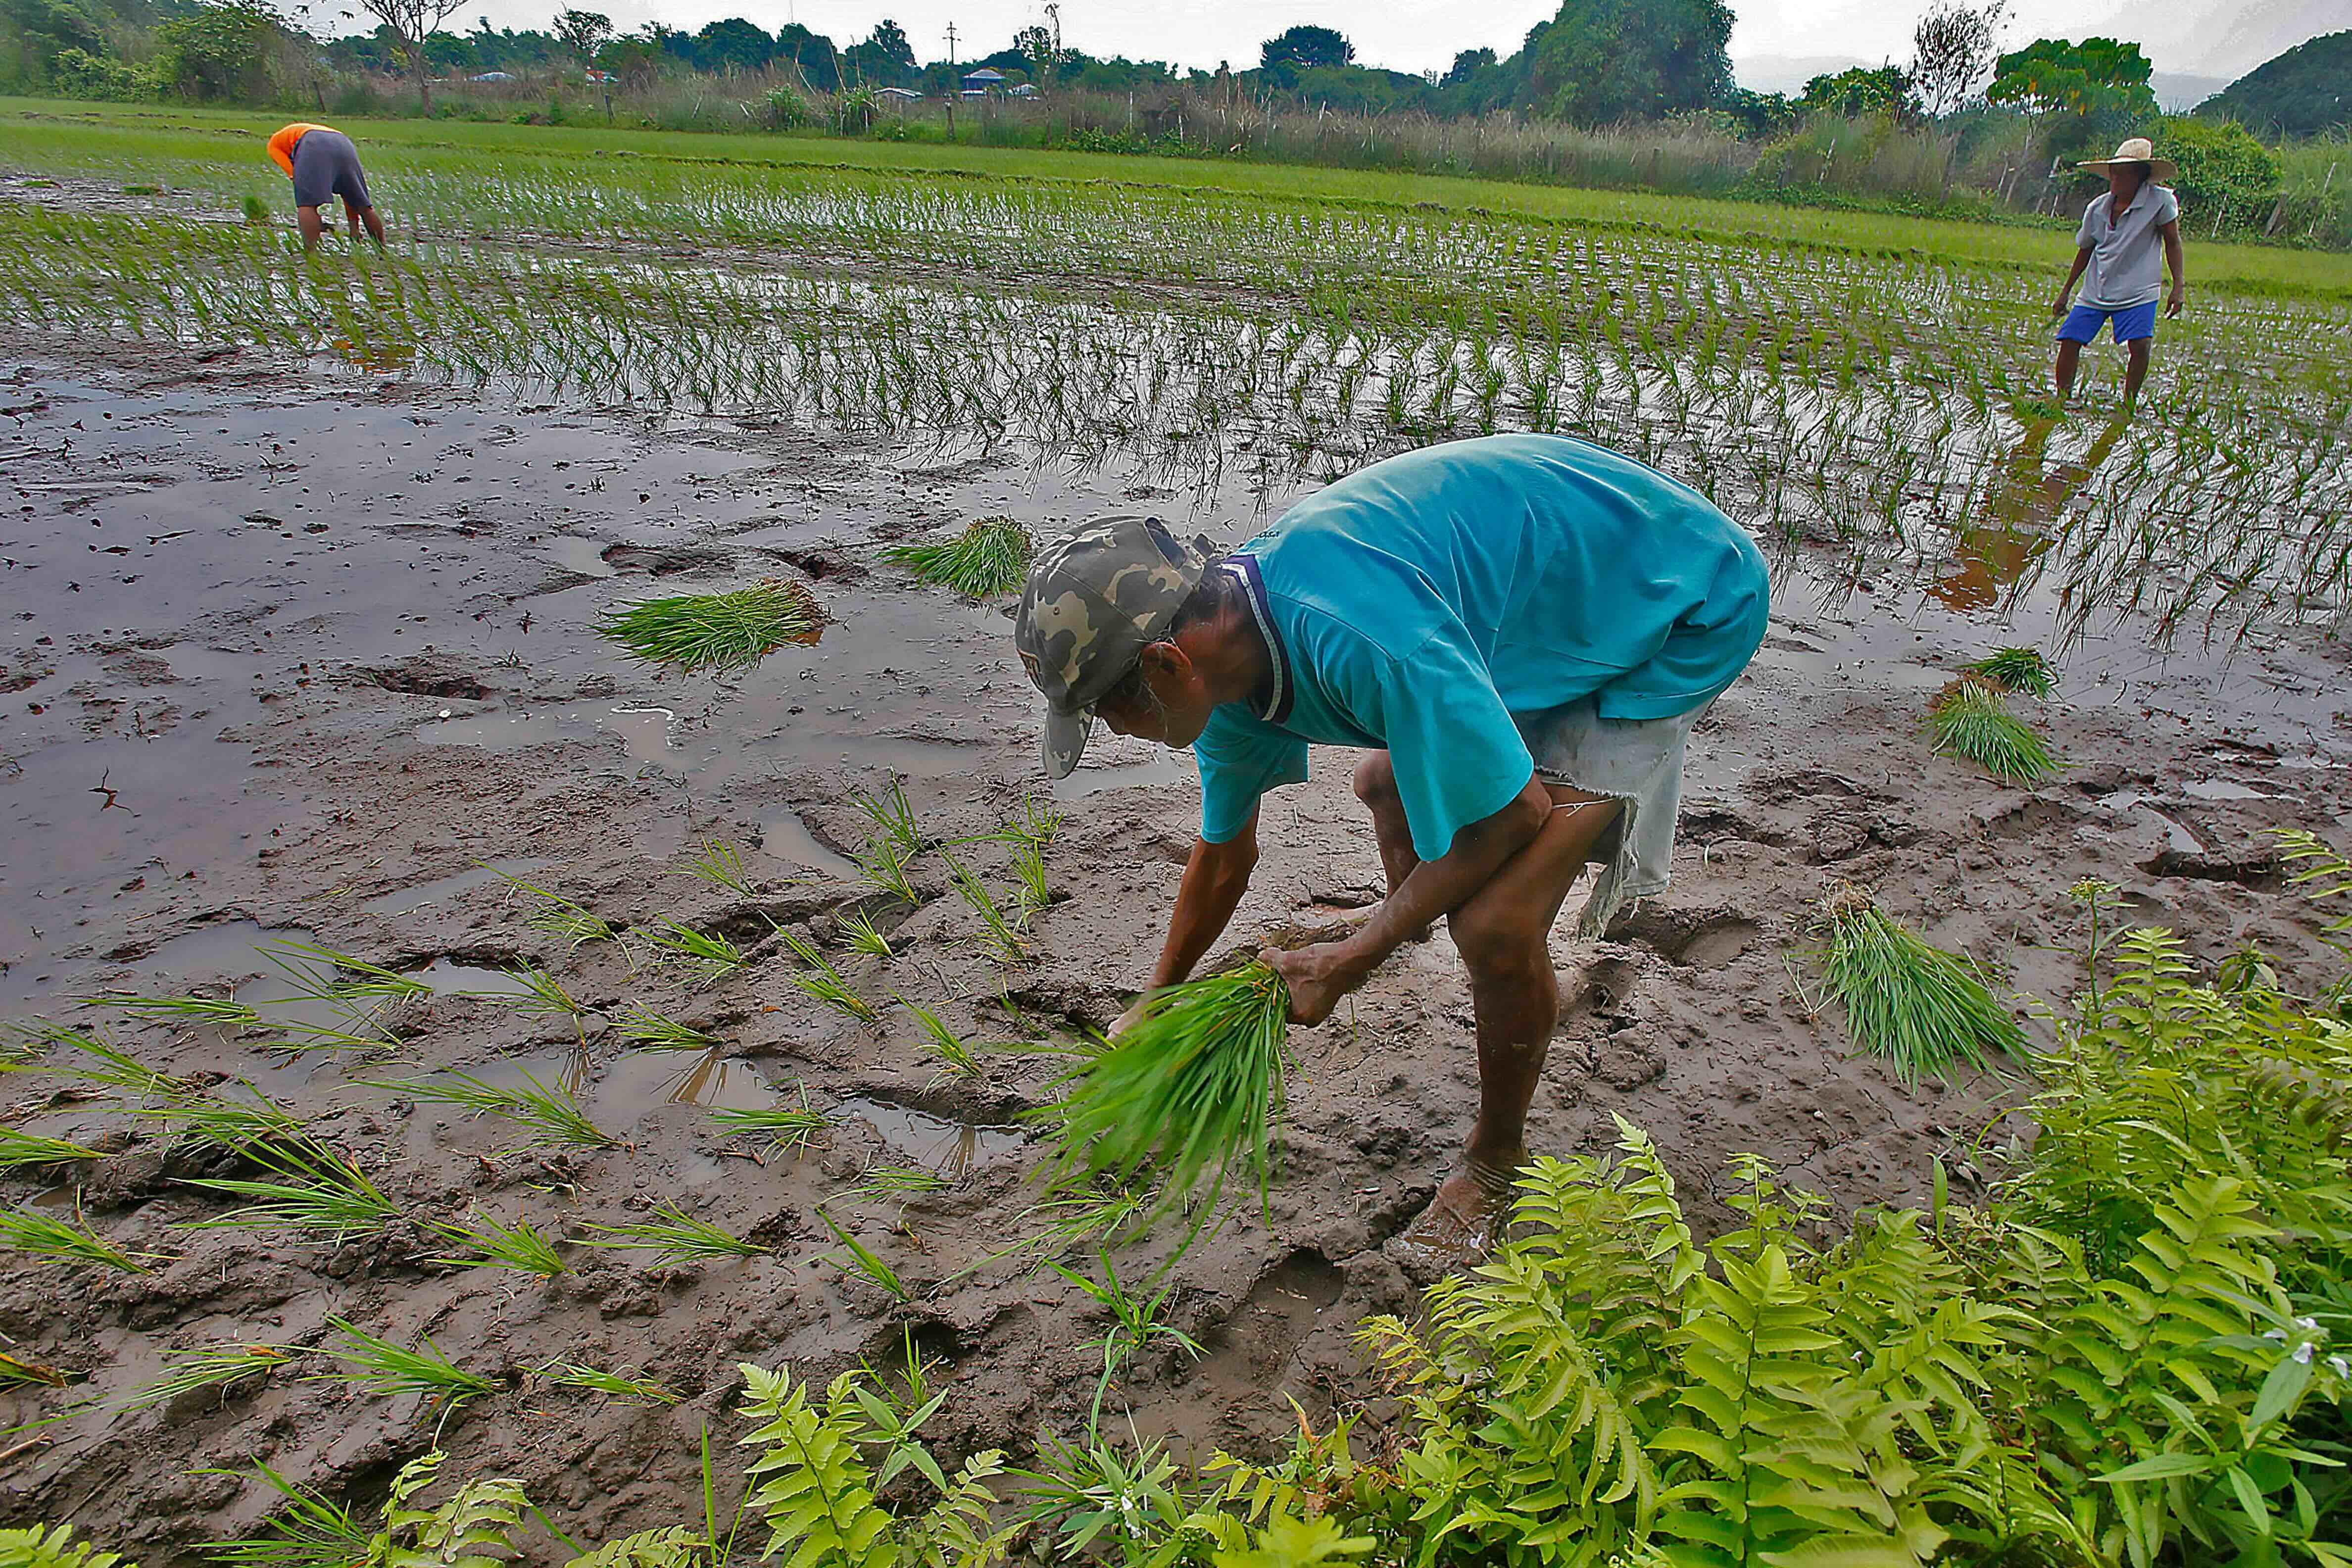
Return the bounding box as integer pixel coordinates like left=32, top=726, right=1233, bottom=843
left=1820, top=888, right=2025, bottom=1084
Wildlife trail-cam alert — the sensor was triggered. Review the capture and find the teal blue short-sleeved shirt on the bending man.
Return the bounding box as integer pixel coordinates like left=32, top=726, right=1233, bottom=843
left=1192, top=435, right=1771, bottom=860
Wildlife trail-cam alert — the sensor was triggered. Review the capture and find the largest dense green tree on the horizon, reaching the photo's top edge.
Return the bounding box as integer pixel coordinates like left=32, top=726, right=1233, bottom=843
left=1526, top=0, right=1731, bottom=125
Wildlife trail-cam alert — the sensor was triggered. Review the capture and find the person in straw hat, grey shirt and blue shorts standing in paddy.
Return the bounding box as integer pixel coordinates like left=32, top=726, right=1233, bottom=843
left=2051, top=136, right=2187, bottom=404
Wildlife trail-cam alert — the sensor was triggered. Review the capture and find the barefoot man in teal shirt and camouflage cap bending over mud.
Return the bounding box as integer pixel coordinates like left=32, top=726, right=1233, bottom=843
left=1014, top=435, right=1769, bottom=1253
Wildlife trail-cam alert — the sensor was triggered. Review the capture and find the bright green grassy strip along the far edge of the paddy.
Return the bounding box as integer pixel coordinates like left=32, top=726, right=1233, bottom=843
left=0, top=98, right=2352, bottom=298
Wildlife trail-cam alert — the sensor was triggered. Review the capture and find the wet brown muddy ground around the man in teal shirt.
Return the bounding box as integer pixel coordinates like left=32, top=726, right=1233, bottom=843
left=0, top=341, right=2352, bottom=1566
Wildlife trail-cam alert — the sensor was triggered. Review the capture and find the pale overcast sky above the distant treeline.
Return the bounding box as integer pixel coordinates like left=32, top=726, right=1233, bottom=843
left=423, top=0, right=2352, bottom=75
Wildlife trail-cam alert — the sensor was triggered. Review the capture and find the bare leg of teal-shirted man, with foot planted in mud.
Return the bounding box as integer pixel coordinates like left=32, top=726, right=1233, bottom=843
left=1414, top=785, right=1620, bottom=1246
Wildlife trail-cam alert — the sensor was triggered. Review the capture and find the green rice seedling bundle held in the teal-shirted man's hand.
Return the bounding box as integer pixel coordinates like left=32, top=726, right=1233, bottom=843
left=1037, top=962, right=1291, bottom=1227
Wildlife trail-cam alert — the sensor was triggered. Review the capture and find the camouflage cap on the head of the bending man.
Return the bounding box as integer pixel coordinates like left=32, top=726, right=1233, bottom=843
left=1014, top=517, right=1209, bottom=778
